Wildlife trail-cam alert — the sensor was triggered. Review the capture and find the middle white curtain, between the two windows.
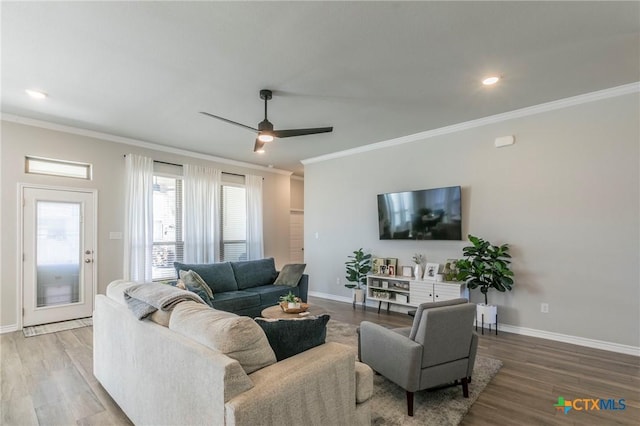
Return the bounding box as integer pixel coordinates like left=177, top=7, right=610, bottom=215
left=183, top=164, right=222, bottom=263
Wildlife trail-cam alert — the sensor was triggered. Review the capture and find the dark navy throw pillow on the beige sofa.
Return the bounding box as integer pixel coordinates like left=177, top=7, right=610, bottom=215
left=254, top=314, right=330, bottom=361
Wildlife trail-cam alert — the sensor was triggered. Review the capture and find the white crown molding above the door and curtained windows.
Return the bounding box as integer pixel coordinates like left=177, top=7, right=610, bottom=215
left=0, top=113, right=293, bottom=176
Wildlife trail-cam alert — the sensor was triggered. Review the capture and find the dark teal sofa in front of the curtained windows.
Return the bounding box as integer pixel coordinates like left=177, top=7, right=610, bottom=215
left=173, top=258, right=309, bottom=317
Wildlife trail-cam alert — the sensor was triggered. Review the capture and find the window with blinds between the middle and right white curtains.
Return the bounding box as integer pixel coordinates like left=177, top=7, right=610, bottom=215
left=220, top=185, right=247, bottom=262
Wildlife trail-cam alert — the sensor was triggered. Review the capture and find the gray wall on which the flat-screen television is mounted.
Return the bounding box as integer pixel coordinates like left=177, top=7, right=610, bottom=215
left=305, top=93, right=640, bottom=347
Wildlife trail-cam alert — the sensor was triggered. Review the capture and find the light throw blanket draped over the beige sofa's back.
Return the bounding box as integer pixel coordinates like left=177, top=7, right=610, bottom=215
left=124, top=283, right=204, bottom=320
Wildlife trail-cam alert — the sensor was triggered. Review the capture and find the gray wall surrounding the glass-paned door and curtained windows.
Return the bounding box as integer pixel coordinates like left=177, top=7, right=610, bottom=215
left=0, top=121, right=291, bottom=327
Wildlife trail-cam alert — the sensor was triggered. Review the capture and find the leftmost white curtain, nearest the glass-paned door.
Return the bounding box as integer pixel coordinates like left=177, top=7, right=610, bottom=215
left=123, top=154, right=153, bottom=282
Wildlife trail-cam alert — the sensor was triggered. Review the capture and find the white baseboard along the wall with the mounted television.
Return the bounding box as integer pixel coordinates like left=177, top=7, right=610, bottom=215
left=309, top=291, right=640, bottom=357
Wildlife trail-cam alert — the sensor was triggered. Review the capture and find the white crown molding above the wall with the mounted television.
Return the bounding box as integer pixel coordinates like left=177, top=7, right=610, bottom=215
left=301, top=82, right=640, bottom=166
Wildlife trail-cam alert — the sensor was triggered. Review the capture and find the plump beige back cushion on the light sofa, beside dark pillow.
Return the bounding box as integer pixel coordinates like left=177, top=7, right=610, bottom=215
left=169, top=302, right=276, bottom=374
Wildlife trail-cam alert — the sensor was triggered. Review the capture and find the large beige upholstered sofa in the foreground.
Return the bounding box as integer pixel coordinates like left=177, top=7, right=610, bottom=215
left=93, top=281, right=373, bottom=426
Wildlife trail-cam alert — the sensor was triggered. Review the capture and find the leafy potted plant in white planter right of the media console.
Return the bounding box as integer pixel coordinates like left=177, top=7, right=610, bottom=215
left=456, top=235, right=513, bottom=331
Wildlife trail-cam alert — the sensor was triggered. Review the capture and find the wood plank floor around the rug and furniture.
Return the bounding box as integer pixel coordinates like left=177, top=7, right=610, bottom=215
left=0, top=298, right=640, bottom=426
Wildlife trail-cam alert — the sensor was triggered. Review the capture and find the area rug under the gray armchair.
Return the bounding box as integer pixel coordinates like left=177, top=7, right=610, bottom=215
left=327, top=320, right=502, bottom=426
